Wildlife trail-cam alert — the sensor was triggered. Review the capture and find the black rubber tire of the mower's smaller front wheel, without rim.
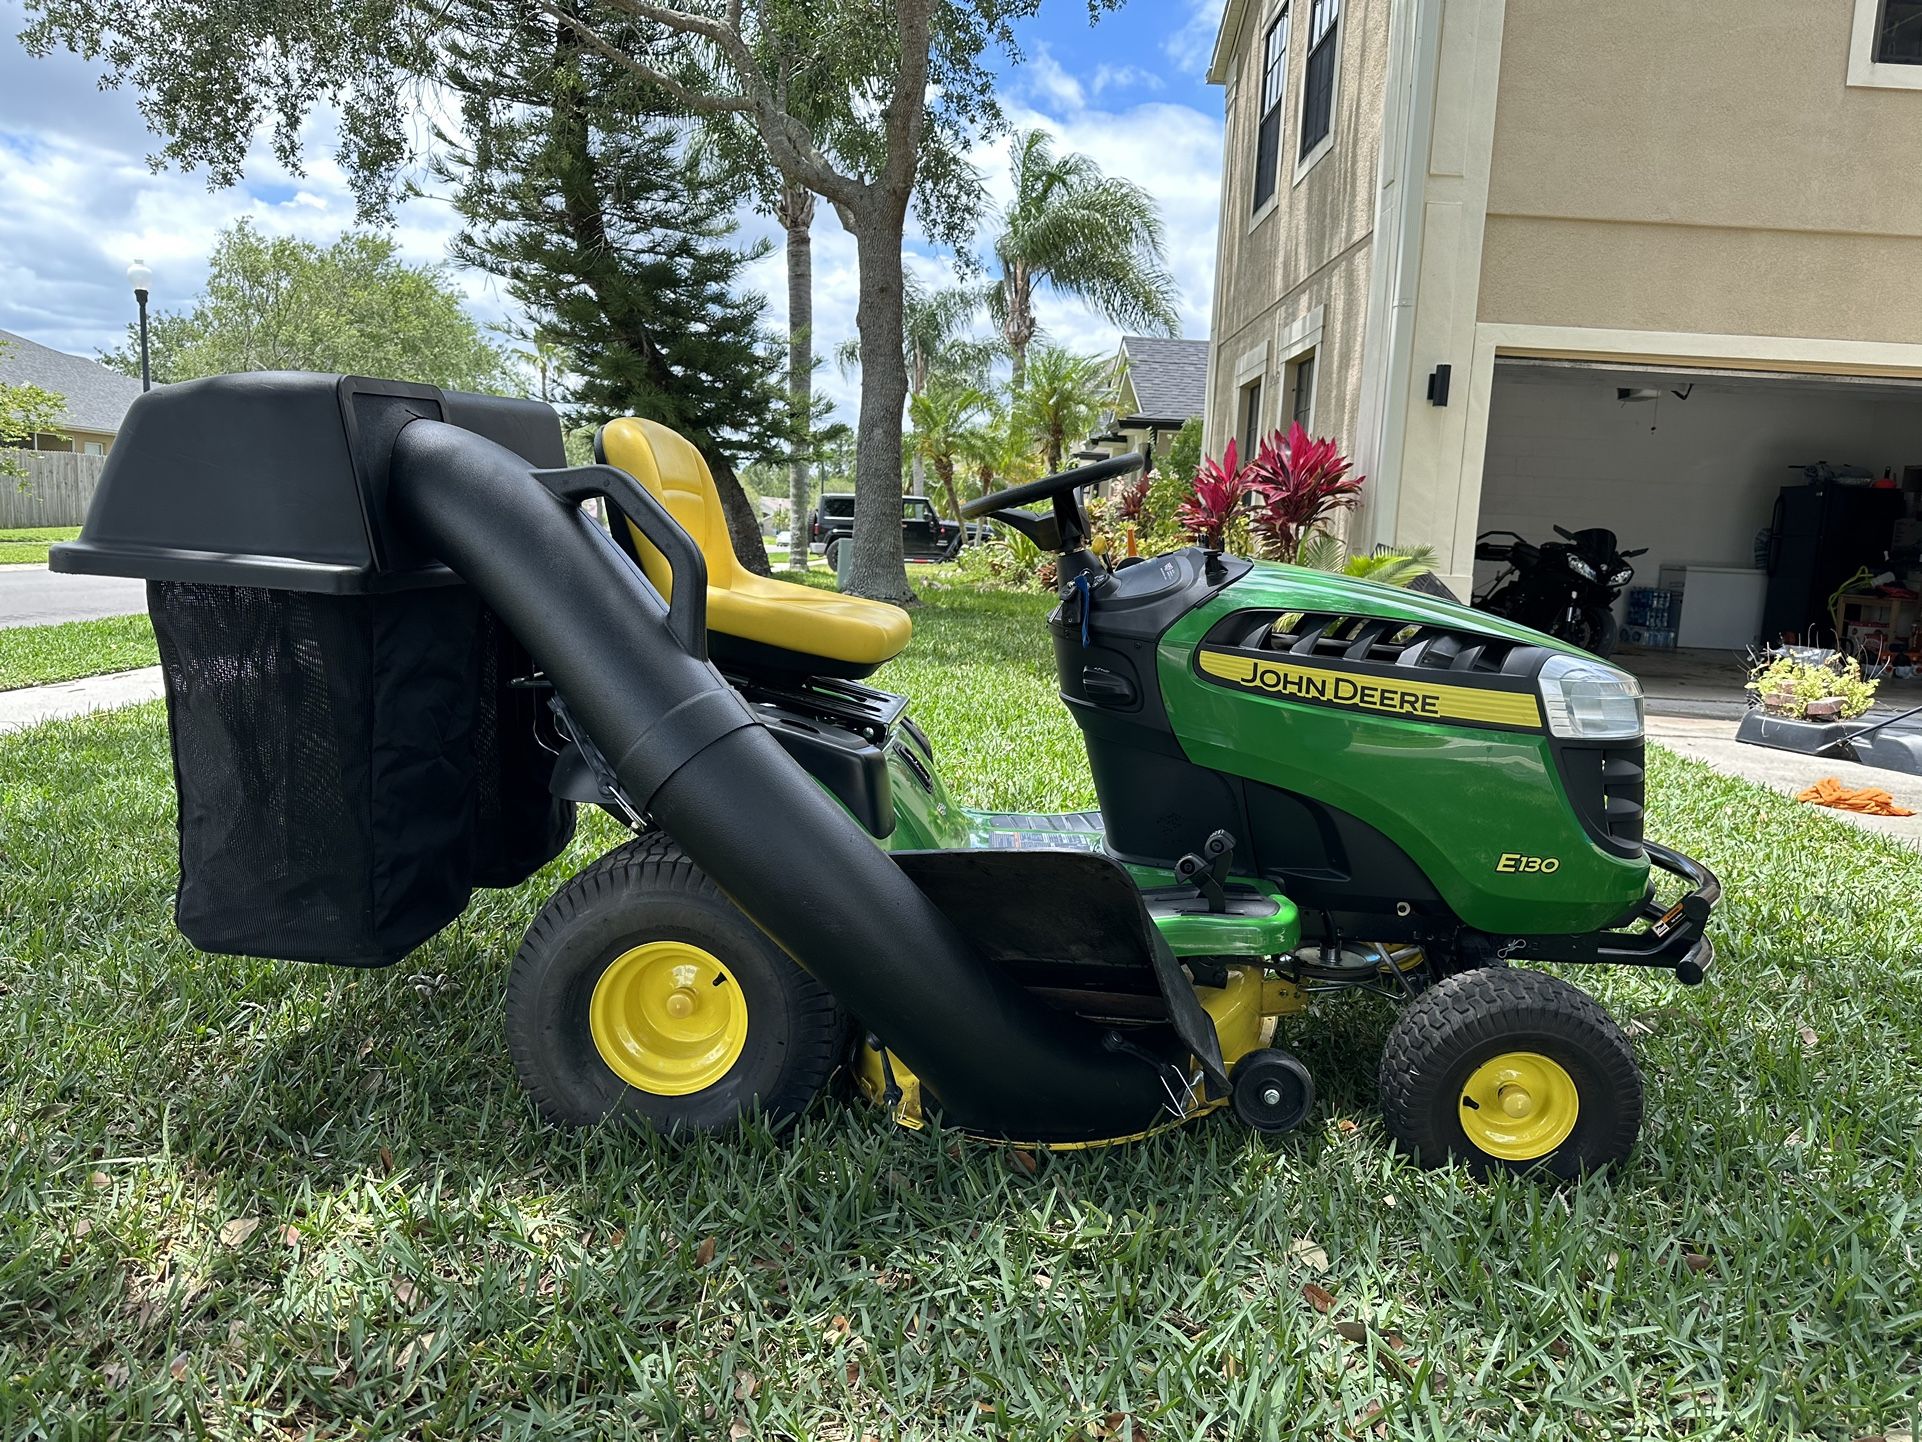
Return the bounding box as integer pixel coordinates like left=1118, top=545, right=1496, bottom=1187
left=1380, top=967, right=1641, bottom=1179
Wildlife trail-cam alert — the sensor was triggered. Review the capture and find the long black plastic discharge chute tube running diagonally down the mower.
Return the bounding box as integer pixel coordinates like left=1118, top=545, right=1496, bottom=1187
left=388, top=419, right=1169, bottom=1142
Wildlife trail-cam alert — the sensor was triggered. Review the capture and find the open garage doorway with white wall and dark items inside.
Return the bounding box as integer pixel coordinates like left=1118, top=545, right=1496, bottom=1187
left=1476, top=358, right=1922, bottom=708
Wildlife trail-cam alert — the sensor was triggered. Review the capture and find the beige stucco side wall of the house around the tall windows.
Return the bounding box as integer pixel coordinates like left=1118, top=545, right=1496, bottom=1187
left=1205, top=0, right=1388, bottom=469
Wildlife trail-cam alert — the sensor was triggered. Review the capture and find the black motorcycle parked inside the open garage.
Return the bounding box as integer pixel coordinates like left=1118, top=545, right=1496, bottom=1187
left=1472, top=527, right=1647, bottom=656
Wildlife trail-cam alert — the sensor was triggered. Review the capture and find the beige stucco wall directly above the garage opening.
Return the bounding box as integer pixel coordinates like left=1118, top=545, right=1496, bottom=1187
left=1480, top=0, right=1922, bottom=342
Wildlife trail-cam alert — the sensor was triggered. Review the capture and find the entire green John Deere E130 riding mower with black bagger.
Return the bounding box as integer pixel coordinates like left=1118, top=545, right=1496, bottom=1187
left=54, top=373, right=1720, bottom=1175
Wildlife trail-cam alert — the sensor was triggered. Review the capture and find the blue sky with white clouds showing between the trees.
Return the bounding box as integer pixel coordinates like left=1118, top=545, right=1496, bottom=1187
left=0, top=0, right=1222, bottom=415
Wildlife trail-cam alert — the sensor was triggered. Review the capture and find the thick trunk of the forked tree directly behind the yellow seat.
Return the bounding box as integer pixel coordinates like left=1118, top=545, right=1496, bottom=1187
left=844, top=216, right=915, bottom=606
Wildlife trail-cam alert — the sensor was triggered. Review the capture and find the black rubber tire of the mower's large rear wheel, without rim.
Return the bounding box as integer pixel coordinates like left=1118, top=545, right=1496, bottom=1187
left=507, top=834, right=848, bottom=1132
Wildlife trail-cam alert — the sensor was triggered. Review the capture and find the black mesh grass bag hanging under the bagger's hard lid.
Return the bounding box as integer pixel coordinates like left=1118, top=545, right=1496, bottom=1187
left=148, top=581, right=573, bottom=965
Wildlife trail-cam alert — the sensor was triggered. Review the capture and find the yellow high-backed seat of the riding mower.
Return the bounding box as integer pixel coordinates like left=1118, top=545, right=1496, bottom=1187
left=594, top=415, right=913, bottom=677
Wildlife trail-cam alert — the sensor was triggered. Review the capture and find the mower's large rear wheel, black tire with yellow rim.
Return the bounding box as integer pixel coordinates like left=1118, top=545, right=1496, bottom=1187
left=507, top=834, right=848, bottom=1131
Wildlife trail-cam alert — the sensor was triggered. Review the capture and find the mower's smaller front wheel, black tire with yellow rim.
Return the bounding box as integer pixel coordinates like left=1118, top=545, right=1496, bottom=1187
left=1380, top=969, right=1641, bottom=1179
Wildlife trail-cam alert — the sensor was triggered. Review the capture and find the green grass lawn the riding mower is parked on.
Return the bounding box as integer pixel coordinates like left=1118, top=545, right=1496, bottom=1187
left=0, top=581, right=1922, bottom=1442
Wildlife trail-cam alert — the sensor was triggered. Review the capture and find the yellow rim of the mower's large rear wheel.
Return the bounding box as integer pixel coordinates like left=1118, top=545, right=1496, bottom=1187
left=588, top=942, right=748, bottom=1096
